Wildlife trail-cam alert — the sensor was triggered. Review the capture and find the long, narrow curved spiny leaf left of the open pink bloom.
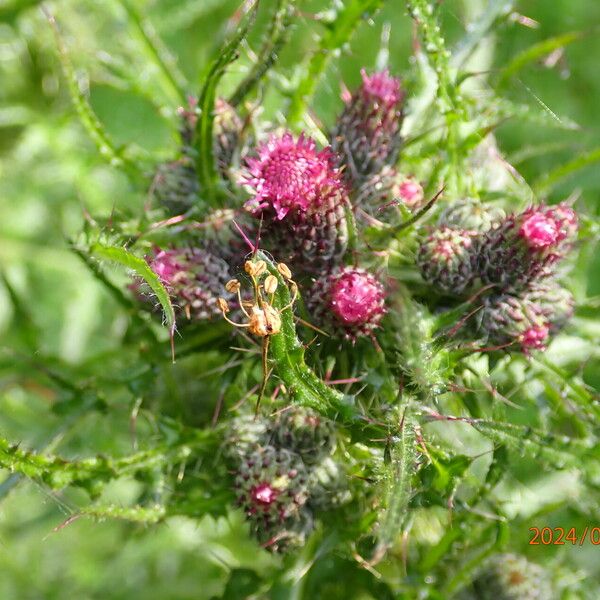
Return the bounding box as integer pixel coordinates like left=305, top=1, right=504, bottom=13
left=194, top=2, right=258, bottom=204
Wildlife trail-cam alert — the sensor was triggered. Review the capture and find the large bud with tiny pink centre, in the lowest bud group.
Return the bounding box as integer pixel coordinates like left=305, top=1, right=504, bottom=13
left=235, top=446, right=308, bottom=548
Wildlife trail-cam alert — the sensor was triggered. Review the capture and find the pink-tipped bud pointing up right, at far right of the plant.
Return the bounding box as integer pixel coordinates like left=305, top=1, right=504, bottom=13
left=478, top=205, right=577, bottom=287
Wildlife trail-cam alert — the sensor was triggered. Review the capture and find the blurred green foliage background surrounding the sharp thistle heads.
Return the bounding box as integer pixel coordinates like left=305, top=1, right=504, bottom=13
left=0, top=0, right=600, bottom=599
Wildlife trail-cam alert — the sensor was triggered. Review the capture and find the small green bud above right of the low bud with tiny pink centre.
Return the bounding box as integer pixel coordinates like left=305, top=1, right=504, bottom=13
left=273, top=407, right=334, bottom=464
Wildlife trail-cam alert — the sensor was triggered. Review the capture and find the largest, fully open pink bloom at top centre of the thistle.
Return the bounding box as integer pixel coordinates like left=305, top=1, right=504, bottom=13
left=243, top=132, right=342, bottom=220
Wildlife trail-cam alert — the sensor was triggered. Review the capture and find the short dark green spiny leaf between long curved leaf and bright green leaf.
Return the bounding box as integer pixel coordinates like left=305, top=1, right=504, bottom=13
left=229, top=0, right=296, bottom=106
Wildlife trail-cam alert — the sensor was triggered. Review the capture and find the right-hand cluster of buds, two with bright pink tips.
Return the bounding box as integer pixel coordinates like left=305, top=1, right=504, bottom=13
left=416, top=200, right=577, bottom=352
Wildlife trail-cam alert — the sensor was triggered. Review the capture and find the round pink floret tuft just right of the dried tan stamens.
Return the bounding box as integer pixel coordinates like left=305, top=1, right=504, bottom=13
left=330, top=268, right=385, bottom=326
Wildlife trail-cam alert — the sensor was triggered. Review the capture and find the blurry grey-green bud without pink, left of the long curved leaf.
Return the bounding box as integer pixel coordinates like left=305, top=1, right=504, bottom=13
left=150, top=157, right=199, bottom=215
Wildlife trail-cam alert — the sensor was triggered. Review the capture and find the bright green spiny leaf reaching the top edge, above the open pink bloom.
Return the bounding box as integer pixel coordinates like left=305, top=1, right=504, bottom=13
left=287, top=0, right=383, bottom=128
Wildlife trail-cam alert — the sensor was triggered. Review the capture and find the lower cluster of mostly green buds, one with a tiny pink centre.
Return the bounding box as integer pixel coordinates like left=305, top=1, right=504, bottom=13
left=223, top=407, right=349, bottom=551
